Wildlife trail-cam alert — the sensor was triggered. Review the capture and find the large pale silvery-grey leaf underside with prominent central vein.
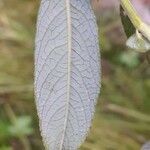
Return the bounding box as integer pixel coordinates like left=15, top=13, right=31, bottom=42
left=35, top=0, right=100, bottom=150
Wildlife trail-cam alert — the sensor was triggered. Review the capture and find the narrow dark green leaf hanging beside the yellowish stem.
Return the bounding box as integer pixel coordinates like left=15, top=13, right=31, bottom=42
left=120, top=5, right=136, bottom=38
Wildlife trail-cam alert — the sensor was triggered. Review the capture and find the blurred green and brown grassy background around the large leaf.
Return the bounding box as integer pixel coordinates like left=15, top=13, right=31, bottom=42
left=0, top=0, right=150, bottom=150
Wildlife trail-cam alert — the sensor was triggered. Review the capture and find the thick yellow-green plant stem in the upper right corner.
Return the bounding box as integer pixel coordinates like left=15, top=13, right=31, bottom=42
left=120, top=0, right=150, bottom=42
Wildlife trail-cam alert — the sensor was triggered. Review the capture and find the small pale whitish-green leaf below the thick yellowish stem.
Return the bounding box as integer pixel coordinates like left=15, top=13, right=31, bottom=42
left=126, top=34, right=150, bottom=53
